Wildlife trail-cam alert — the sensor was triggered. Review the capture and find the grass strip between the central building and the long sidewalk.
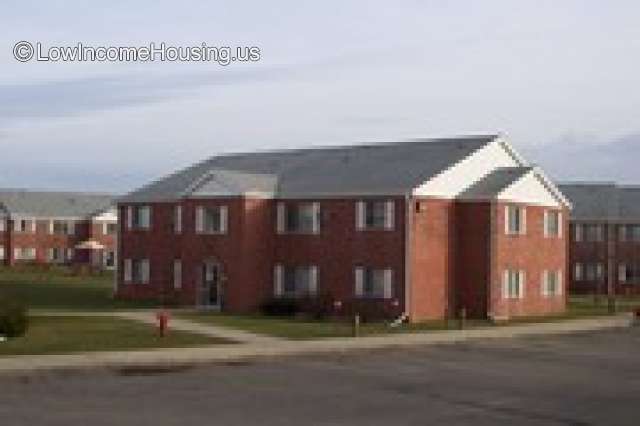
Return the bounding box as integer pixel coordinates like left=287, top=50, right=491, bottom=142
left=179, top=297, right=640, bottom=340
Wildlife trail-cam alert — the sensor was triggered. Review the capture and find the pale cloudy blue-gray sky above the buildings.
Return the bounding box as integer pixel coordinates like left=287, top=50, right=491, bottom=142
left=0, top=0, right=640, bottom=193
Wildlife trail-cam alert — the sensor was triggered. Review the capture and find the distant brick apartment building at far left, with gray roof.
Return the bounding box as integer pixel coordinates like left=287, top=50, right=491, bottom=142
left=0, top=190, right=117, bottom=268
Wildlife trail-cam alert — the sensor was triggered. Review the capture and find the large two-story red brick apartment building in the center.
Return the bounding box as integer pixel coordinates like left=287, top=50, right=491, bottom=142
left=117, top=136, right=570, bottom=321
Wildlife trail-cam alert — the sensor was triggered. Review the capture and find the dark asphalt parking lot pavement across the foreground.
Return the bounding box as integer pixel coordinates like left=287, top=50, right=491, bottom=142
left=0, top=328, right=640, bottom=426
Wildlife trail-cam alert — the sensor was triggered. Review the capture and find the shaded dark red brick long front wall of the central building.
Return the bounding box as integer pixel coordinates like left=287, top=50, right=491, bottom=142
left=118, top=198, right=404, bottom=312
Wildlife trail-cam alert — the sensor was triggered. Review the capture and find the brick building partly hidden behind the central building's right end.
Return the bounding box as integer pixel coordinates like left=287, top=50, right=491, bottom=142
left=561, top=183, right=640, bottom=294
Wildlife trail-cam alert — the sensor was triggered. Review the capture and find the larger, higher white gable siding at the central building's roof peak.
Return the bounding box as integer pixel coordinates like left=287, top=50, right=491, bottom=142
left=413, top=140, right=525, bottom=198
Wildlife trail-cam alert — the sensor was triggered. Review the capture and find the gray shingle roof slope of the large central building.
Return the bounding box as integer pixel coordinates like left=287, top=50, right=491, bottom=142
left=119, top=135, right=497, bottom=202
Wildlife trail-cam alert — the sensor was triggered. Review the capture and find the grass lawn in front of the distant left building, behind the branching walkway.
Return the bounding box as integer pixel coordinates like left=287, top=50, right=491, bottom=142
left=0, top=267, right=153, bottom=310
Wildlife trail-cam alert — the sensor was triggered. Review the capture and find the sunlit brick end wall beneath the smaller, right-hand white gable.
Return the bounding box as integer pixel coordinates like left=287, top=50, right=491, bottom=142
left=489, top=203, right=569, bottom=317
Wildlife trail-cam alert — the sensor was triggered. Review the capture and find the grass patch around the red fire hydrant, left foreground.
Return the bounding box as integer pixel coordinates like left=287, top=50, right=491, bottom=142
left=0, top=317, right=230, bottom=357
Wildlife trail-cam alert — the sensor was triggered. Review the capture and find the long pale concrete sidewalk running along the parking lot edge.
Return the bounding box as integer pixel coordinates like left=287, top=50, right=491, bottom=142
left=0, top=314, right=633, bottom=374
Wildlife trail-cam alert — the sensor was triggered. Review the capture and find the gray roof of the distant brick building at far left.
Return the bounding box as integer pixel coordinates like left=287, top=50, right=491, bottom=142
left=0, top=189, right=114, bottom=218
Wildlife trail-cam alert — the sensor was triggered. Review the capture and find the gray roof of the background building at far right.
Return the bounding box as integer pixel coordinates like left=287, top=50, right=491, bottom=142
left=558, top=182, right=640, bottom=221
